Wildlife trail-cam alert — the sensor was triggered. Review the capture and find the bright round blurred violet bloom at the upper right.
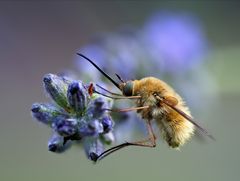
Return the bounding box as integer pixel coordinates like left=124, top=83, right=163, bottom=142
left=142, top=12, right=208, bottom=73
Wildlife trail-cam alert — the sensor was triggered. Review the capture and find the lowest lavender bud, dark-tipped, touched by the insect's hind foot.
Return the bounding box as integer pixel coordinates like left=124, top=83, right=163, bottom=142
left=83, top=137, right=104, bottom=161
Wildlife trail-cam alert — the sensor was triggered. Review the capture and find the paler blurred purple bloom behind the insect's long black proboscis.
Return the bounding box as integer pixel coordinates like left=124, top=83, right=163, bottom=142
left=77, top=31, right=143, bottom=80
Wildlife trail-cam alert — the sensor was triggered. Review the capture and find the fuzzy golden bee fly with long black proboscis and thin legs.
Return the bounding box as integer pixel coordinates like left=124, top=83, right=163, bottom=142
left=77, top=53, right=214, bottom=161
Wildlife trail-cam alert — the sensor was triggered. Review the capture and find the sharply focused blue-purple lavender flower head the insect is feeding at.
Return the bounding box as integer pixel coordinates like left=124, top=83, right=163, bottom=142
left=31, top=74, right=114, bottom=161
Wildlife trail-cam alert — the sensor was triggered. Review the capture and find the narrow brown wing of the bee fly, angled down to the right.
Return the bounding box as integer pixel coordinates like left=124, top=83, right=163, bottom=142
left=162, top=99, right=216, bottom=141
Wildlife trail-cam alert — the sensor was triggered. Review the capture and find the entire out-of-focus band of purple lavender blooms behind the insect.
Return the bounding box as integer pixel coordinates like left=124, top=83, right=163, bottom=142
left=78, top=11, right=208, bottom=78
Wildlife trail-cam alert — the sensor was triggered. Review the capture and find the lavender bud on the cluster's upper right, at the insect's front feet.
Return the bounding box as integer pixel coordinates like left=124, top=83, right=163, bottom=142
left=87, top=97, right=108, bottom=118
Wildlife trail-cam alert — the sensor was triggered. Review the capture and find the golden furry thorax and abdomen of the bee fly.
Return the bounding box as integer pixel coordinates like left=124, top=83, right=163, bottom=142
left=130, top=77, right=194, bottom=148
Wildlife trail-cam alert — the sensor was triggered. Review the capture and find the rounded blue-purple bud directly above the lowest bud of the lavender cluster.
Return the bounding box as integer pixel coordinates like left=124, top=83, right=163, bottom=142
left=79, top=120, right=103, bottom=137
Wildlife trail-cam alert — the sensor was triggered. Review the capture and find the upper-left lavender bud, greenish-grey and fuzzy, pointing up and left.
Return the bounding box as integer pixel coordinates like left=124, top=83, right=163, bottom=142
left=43, top=74, right=70, bottom=111
